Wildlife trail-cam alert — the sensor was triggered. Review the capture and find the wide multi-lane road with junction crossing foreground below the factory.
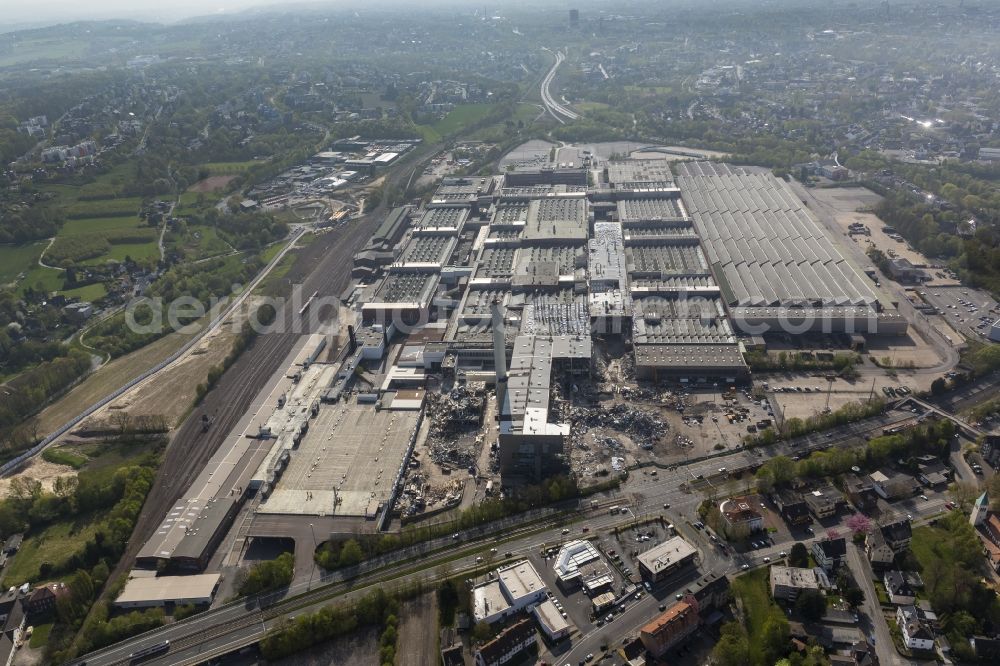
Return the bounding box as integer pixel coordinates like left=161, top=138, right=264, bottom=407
left=75, top=402, right=931, bottom=666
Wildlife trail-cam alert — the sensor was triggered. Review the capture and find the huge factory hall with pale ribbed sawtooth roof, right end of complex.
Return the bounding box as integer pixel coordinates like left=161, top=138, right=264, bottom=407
left=678, top=162, right=907, bottom=335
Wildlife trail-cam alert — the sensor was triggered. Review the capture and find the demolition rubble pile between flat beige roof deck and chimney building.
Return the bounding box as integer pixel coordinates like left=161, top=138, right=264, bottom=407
left=427, top=382, right=487, bottom=470
